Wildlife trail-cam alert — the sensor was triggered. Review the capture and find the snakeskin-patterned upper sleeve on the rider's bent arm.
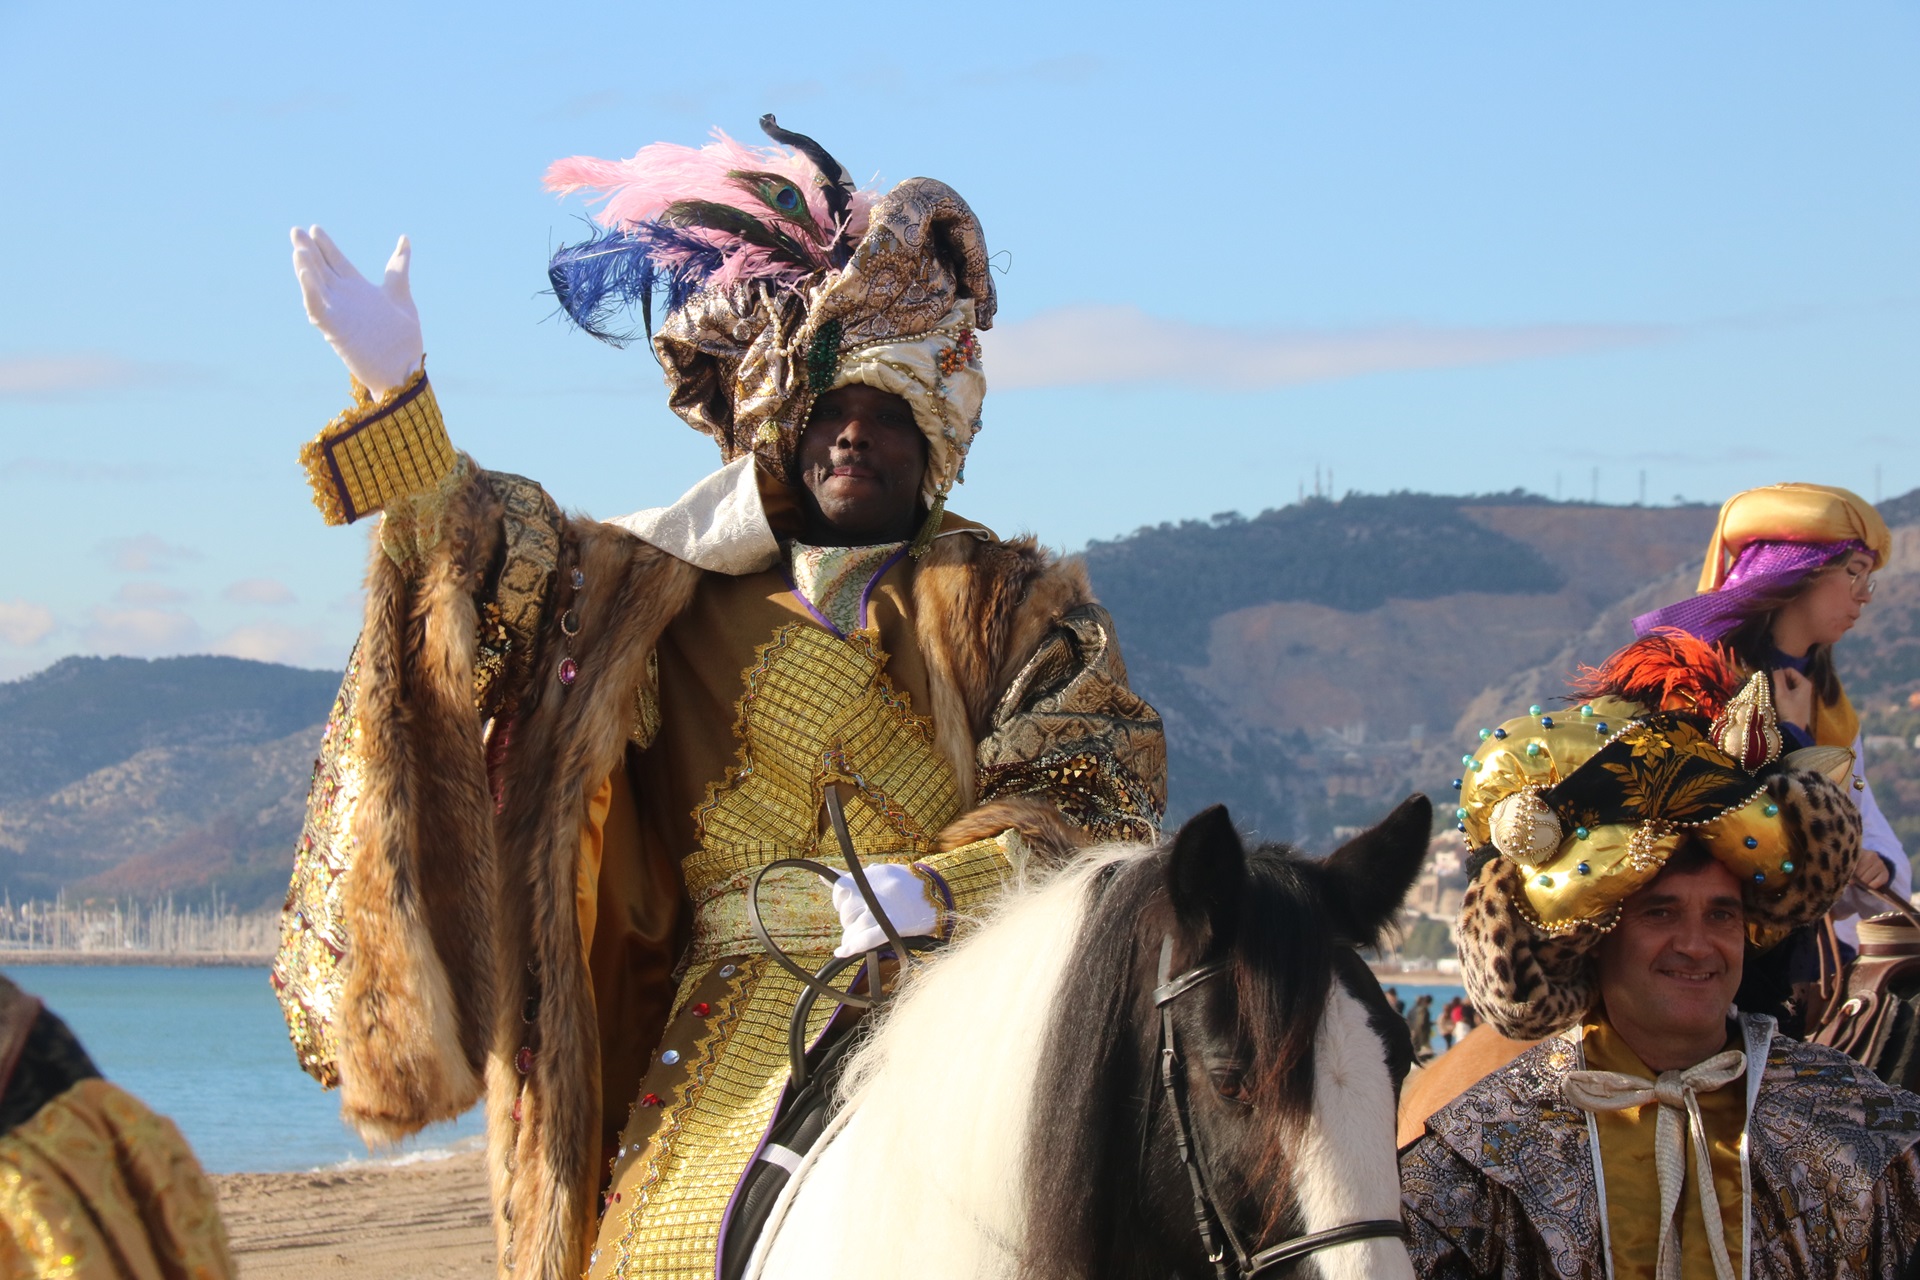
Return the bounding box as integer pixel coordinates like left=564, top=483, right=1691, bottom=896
left=977, top=604, right=1167, bottom=841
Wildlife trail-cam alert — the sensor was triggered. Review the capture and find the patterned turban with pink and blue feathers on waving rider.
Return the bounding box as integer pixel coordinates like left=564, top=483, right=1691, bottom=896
left=545, top=115, right=995, bottom=547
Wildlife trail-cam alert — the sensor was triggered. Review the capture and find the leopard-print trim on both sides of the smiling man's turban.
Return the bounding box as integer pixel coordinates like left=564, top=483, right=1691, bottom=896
left=1455, top=770, right=1860, bottom=1040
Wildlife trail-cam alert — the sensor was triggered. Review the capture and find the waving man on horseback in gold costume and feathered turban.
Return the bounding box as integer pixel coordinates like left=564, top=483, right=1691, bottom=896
left=275, top=117, right=1165, bottom=1278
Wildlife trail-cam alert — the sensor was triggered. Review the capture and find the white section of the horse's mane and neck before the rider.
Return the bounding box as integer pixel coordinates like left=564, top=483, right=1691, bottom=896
left=839, top=844, right=1142, bottom=1278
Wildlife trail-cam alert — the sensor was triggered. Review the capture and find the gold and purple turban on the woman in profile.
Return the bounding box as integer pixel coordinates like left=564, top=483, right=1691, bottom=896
left=1634, top=484, right=1893, bottom=641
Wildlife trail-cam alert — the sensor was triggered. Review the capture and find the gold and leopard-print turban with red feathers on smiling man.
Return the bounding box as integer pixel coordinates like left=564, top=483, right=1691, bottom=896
left=1455, top=631, right=1860, bottom=1038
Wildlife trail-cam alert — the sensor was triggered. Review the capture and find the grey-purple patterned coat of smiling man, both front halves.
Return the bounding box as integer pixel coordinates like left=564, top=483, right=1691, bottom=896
left=1400, top=1019, right=1920, bottom=1280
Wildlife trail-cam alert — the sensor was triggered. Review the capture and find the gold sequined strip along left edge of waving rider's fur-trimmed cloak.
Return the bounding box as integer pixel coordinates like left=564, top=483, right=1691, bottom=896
left=269, top=649, right=365, bottom=1088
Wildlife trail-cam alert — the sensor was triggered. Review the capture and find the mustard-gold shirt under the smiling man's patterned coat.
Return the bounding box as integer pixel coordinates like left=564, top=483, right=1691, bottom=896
left=1580, top=1019, right=1747, bottom=1280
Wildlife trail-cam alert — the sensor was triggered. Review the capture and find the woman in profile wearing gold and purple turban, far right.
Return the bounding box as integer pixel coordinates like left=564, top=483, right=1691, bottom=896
left=1634, top=484, right=1912, bottom=948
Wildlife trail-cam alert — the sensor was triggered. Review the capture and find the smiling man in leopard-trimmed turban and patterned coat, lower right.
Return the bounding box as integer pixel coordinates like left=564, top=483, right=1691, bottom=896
left=1402, top=633, right=1920, bottom=1280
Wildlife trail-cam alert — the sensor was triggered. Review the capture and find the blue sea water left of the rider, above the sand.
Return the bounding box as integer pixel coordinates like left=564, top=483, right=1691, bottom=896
left=8, top=965, right=484, bottom=1173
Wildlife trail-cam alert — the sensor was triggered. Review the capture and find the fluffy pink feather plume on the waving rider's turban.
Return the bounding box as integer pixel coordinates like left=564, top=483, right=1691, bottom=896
left=543, top=129, right=877, bottom=286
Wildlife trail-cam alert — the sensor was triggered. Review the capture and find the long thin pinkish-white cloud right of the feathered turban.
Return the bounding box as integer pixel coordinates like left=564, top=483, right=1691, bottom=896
left=981, top=307, right=1670, bottom=390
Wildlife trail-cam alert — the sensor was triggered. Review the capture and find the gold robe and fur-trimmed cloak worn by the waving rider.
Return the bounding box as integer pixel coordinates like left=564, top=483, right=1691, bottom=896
left=276, top=470, right=1165, bottom=1278
